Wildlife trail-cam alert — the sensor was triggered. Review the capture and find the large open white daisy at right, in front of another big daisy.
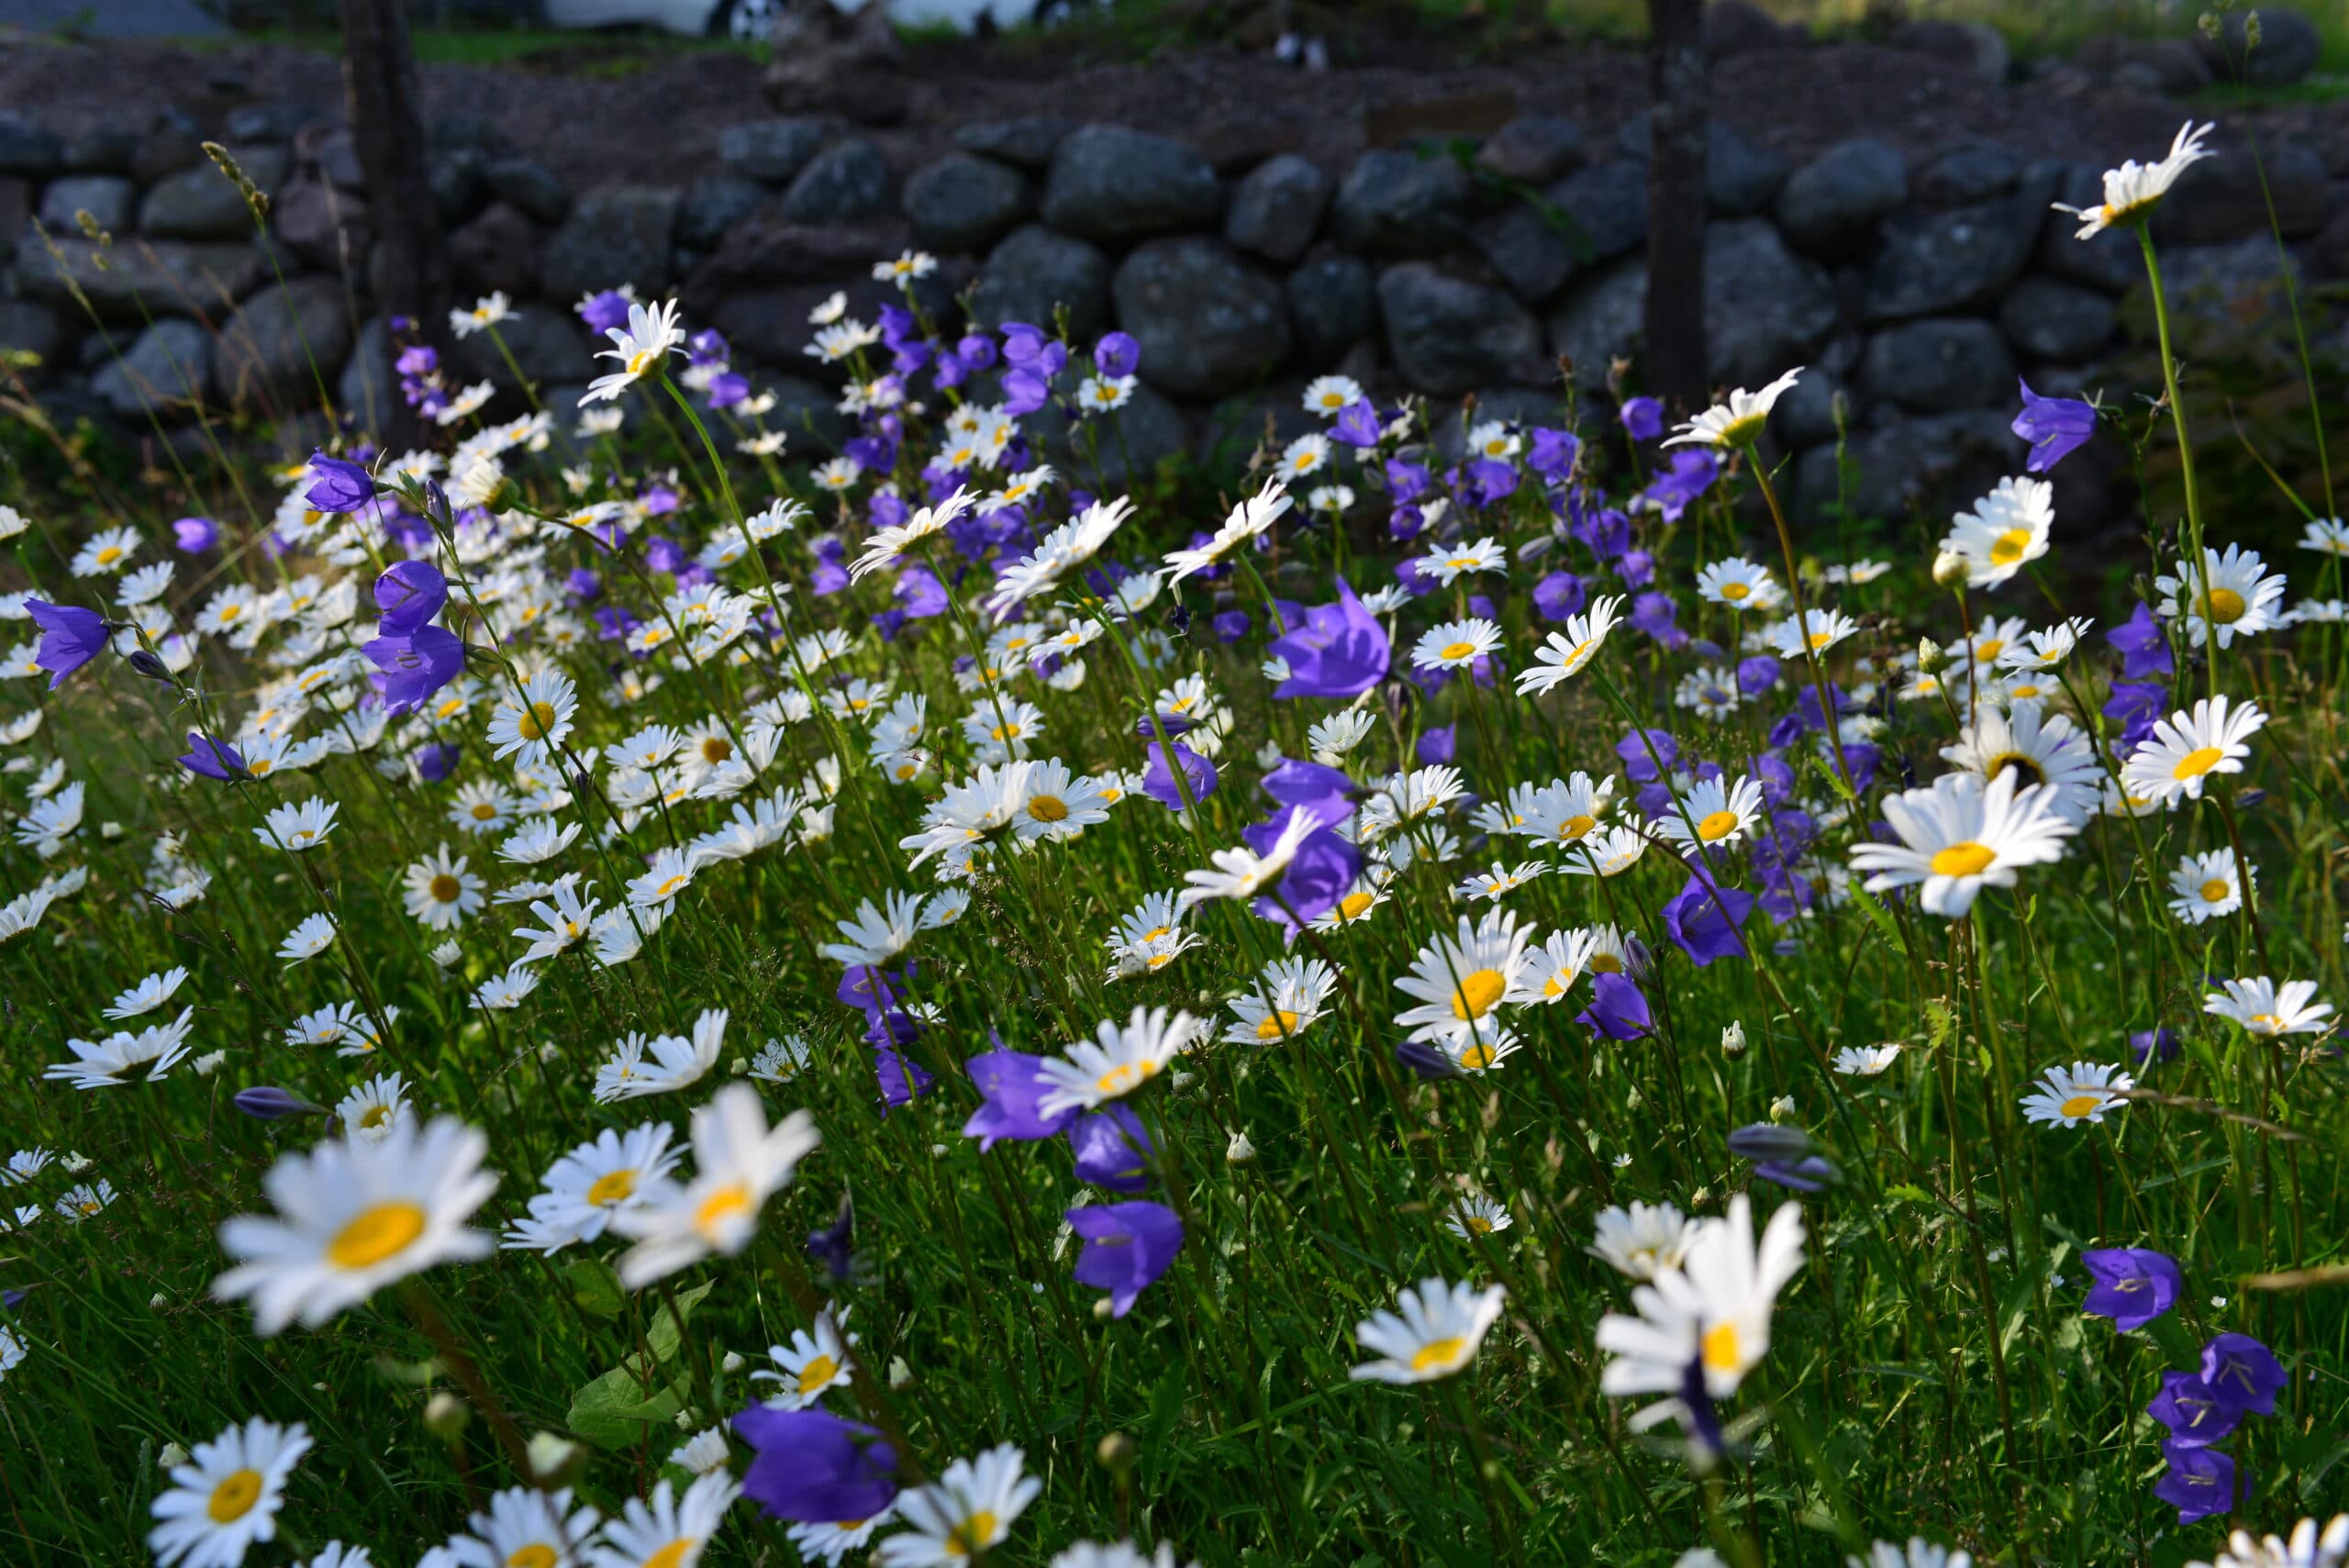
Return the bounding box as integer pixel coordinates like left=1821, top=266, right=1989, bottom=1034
left=1851, top=770, right=2076, bottom=920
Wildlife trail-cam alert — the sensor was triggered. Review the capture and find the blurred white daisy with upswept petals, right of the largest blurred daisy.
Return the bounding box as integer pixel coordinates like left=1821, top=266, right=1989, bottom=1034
left=611, top=1084, right=822, bottom=1291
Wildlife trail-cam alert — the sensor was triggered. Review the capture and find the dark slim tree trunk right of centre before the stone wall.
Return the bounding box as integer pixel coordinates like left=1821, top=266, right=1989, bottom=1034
left=1644, top=0, right=1712, bottom=408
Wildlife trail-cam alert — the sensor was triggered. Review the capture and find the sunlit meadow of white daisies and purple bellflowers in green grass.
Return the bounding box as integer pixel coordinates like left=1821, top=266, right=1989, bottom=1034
left=0, top=127, right=2349, bottom=1568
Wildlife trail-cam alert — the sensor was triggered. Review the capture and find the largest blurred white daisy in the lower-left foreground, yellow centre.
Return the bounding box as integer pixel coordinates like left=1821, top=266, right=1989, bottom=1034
left=211, top=1118, right=498, bottom=1336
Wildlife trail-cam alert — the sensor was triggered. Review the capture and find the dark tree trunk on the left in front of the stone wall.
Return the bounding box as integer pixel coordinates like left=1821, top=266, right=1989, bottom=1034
left=340, top=0, right=449, bottom=450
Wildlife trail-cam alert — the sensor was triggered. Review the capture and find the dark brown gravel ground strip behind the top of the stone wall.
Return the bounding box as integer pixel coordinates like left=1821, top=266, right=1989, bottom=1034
left=0, top=26, right=2349, bottom=190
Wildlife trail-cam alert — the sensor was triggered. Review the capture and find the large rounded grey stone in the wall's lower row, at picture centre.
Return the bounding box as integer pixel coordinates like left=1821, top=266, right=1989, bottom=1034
left=1111, top=235, right=1289, bottom=399
